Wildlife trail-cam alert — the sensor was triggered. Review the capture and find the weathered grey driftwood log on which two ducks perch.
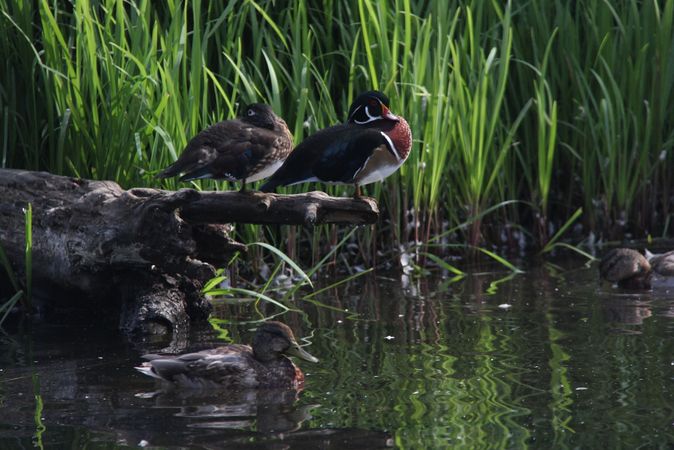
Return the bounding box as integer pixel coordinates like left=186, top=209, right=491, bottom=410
left=0, top=170, right=378, bottom=334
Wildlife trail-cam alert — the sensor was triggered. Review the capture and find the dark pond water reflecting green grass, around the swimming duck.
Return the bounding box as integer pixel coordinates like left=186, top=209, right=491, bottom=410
left=0, top=255, right=674, bottom=449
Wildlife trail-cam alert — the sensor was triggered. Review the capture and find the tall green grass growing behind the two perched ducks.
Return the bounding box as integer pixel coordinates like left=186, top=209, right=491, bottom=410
left=0, top=0, right=674, bottom=264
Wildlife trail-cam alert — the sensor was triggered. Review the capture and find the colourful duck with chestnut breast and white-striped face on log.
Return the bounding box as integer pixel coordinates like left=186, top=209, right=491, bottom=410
left=260, top=91, right=412, bottom=197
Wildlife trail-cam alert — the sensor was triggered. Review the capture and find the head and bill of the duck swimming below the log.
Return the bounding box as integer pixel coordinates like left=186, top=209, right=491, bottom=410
left=253, top=322, right=318, bottom=362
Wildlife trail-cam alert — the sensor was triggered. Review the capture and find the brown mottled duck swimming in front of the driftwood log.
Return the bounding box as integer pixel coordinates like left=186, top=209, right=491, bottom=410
left=136, top=321, right=318, bottom=389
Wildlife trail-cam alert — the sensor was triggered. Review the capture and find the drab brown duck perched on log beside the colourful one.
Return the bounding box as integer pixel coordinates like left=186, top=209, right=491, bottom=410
left=157, top=103, right=293, bottom=191
